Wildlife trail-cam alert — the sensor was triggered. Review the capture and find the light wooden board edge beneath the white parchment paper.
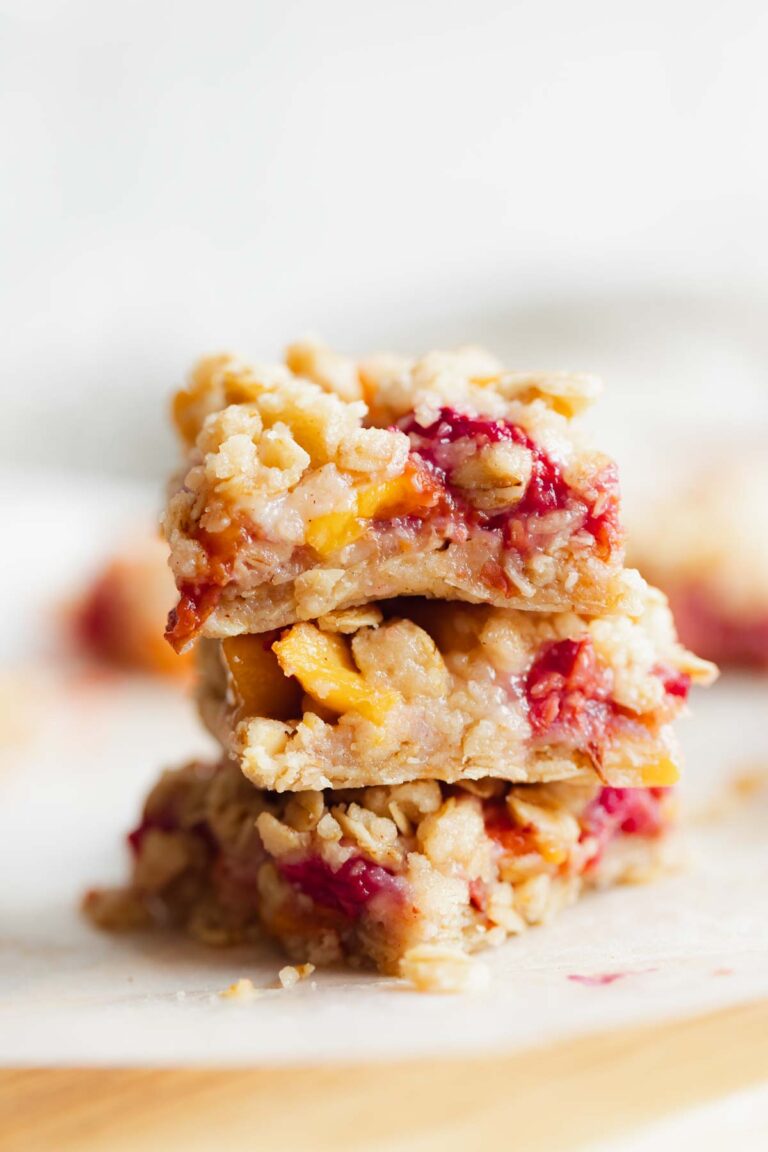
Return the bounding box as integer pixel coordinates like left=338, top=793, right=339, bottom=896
left=0, top=1000, right=768, bottom=1152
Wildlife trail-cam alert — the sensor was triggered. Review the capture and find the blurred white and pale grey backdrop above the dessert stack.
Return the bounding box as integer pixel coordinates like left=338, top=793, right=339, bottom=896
left=0, top=0, right=768, bottom=490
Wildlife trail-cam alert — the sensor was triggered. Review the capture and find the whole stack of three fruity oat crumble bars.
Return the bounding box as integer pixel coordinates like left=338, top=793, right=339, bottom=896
left=88, top=342, right=715, bottom=987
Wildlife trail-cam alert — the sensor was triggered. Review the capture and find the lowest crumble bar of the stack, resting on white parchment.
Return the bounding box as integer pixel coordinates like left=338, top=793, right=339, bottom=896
left=85, top=761, right=674, bottom=987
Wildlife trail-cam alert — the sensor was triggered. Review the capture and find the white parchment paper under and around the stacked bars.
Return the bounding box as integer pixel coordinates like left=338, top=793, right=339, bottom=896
left=0, top=482, right=768, bottom=1063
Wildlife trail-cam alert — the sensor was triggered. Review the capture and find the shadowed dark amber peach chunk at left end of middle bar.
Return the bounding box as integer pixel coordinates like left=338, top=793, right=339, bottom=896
left=221, top=632, right=302, bottom=720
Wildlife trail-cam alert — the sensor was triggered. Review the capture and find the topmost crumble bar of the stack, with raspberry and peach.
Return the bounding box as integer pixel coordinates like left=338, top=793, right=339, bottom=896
left=165, top=342, right=641, bottom=651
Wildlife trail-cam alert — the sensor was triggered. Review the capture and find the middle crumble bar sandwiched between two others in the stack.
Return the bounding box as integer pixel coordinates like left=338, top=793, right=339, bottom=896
left=199, top=590, right=715, bottom=791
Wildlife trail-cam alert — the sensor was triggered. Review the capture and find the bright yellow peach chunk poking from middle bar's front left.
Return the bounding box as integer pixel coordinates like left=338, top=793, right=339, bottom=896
left=272, top=623, right=400, bottom=723
